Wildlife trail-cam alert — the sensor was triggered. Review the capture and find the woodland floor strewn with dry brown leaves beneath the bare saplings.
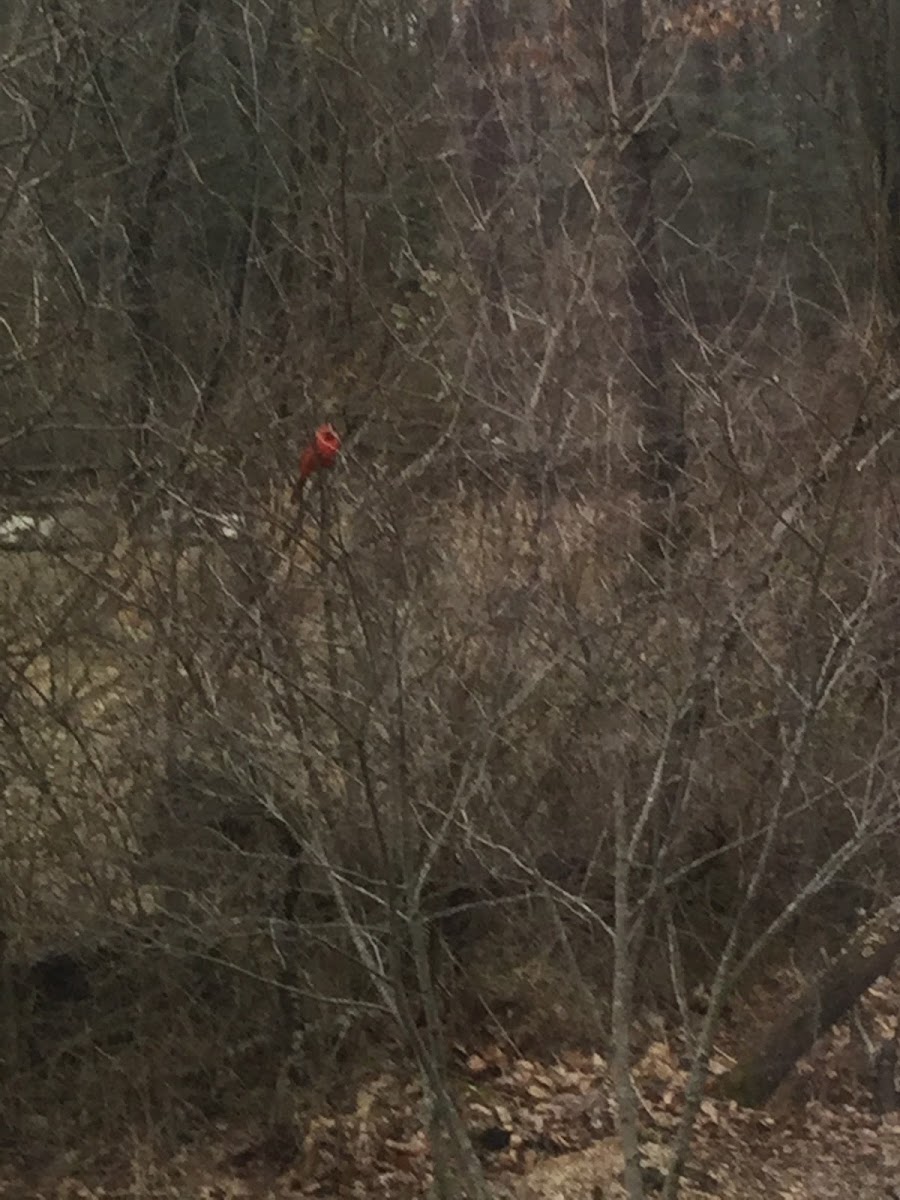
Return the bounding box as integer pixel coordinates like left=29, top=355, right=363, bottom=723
left=0, top=976, right=900, bottom=1200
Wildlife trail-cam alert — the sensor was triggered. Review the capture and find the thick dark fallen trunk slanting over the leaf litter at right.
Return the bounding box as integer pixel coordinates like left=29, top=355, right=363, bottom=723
left=716, top=896, right=900, bottom=1108
